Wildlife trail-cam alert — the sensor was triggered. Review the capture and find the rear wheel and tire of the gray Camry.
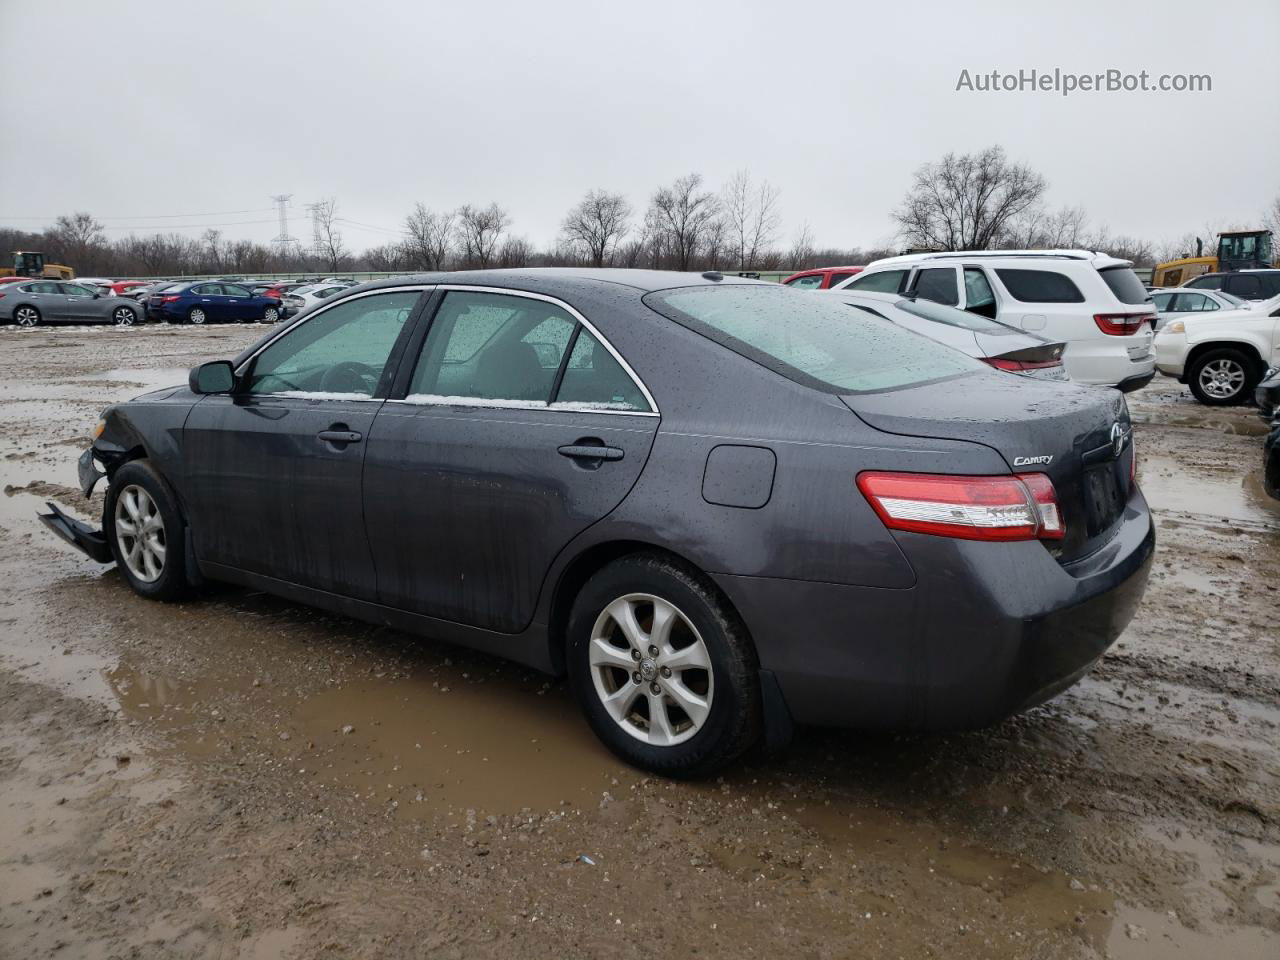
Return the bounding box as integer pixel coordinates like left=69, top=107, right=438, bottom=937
left=567, top=554, right=763, bottom=777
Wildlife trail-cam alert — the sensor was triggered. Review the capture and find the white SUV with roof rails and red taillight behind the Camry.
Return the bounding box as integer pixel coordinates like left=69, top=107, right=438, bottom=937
left=833, top=256, right=1156, bottom=390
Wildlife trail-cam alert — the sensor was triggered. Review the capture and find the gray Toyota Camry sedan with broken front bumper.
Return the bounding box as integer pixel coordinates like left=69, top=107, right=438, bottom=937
left=45, top=270, right=1155, bottom=776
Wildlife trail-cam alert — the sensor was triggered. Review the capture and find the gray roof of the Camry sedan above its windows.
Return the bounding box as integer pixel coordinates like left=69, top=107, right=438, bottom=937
left=350, top=266, right=762, bottom=293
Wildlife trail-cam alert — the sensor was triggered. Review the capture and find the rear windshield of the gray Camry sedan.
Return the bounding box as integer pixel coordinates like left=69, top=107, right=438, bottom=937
left=644, top=284, right=986, bottom=393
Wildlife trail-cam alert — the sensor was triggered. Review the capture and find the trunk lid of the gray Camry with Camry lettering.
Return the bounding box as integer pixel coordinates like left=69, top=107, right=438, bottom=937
left=842, top=372, right=1134, bottom=563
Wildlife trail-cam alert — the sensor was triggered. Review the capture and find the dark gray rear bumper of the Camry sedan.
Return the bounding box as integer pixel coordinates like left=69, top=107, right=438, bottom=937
left=716, top=492, right=1155, bottom=731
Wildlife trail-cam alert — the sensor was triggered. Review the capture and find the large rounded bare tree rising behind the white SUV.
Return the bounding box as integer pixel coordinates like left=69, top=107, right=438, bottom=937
left=893, top=146, right=1046, bottom=250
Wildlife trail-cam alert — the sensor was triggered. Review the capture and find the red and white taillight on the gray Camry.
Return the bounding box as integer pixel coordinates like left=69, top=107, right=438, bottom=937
left=858, top=472, right=1064, bottom=540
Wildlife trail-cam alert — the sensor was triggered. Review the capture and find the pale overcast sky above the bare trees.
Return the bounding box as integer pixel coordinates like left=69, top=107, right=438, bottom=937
left=0, top=0, right=1280, bottom=256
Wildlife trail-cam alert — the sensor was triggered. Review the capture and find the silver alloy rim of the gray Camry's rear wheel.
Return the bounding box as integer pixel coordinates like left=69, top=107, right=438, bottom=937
left=588, top=594, right=714, bottom=746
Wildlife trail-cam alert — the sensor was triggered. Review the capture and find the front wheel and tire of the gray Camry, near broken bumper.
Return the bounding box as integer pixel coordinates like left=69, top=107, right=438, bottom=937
left=102, top=460, right=188, bottom=600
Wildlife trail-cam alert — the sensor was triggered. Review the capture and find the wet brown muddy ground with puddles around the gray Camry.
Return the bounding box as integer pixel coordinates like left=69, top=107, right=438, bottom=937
left=0, top=326, right=1280, bottom=960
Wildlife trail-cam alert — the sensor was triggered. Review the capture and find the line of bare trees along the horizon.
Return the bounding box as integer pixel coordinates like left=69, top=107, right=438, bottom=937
left=0, top=154, right=1280, bottom=276
